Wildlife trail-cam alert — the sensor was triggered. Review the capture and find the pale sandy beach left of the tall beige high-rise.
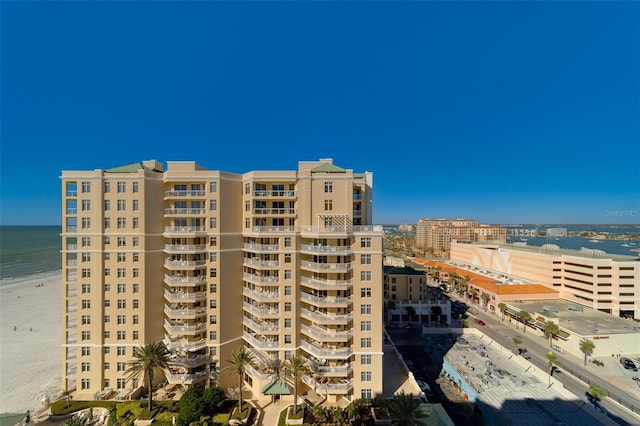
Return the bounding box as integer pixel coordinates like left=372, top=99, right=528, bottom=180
left=0, top=271, right=62, bottom=413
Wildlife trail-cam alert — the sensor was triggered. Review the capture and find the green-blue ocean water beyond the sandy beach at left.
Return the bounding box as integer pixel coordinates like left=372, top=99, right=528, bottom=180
left=0, top=226, right=62, bottom=283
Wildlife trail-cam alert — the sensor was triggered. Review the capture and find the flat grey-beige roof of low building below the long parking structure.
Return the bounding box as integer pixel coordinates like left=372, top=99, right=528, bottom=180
left=505, top=299, right=640, bottom=337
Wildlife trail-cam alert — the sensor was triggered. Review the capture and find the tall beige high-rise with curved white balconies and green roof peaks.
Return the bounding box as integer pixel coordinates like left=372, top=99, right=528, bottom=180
left=61, top=159, right=383, bottom=401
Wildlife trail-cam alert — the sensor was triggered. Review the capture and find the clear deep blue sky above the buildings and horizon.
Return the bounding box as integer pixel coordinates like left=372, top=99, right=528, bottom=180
left=0, top=2, right=640, bottom=225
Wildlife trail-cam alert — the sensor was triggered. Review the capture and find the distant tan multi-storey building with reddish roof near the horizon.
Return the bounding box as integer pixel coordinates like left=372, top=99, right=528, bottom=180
left=416, top=219, right=507, bottom=257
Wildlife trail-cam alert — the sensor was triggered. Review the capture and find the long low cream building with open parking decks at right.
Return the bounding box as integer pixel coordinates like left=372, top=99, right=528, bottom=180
left=451, top=243, right=640, bottom=318
